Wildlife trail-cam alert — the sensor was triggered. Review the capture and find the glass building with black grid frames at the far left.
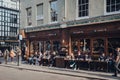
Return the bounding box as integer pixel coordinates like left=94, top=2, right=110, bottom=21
left=0, top=0, right=19, bottom=50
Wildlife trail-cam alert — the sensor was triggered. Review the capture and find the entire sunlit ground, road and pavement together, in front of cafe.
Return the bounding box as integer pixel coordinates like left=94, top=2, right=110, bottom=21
left=0, top=58, right=120, bottom=80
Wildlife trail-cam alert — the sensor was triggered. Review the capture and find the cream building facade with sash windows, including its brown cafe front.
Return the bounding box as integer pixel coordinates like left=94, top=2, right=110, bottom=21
left=21, top=0, right=120, bottom=55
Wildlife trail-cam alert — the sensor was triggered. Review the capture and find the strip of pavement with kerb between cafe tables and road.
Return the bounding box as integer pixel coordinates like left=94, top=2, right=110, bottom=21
left=0, top=62, right=120, bottom=80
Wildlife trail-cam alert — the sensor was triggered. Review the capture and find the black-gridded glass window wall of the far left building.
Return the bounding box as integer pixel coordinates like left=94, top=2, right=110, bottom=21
left=0, top=8, right=19, bottom=40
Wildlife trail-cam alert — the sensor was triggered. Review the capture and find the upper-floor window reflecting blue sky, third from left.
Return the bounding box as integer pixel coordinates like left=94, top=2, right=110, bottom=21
left=50, top=0, right=58, bottom=22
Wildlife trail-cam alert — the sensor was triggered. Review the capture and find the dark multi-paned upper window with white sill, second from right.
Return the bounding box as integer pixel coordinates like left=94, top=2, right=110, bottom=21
left=77, top=0, right=89, bottom=17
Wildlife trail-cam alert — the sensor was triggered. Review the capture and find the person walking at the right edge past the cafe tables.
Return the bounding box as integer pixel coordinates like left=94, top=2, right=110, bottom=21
left=112, top=47, right=120, bottom=77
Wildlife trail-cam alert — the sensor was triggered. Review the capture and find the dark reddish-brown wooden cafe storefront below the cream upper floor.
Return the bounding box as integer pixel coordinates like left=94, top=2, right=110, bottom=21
left=23, top=21, right=120, bottom=55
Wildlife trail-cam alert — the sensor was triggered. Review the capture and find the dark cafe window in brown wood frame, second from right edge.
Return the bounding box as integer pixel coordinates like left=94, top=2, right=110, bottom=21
left=93, top=39, right=104, bottom=54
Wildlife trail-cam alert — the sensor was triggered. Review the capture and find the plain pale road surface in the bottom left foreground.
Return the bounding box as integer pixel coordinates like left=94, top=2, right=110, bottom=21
left=0, top=66, right=90, bottom=80
